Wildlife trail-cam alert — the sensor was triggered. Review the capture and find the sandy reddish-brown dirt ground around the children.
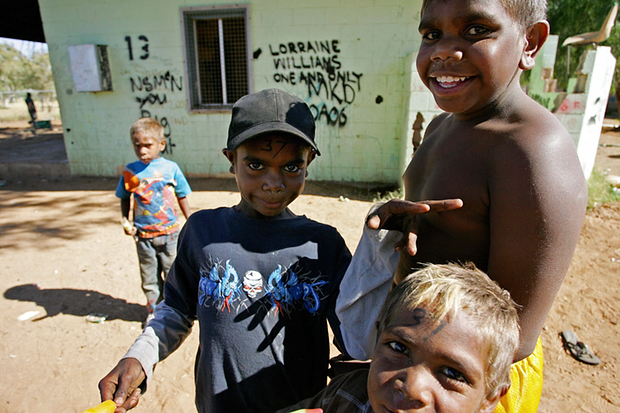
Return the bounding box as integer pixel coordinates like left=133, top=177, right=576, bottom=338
left=0, top=123, right=620, bottom=413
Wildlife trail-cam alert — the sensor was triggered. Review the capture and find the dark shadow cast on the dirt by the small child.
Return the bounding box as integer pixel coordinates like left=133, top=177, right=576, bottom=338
left=4, top=284, right=147, bottom=322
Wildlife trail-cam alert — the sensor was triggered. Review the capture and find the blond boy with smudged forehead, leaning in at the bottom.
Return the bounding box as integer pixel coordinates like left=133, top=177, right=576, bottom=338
left=279, top=264, right=519, bottom=413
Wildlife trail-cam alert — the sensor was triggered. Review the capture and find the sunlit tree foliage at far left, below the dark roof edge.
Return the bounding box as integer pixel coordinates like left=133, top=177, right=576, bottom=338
left=0, top=44, right=54, bottom=92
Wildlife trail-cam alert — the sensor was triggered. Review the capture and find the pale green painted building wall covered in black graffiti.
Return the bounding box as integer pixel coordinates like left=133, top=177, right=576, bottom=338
left=39, top=0, right=438, bottom=183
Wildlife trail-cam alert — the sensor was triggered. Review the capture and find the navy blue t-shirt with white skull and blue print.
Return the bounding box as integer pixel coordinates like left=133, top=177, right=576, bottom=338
left=165, top=208, right=351, bottom=413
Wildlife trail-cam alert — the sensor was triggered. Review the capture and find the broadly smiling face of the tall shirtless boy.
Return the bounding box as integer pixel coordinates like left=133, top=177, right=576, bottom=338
left=417, top=0, right=526, bottom=116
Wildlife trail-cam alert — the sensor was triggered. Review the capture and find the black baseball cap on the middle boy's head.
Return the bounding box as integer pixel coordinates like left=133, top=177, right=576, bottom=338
left=226, top=89, right=321, bottom=155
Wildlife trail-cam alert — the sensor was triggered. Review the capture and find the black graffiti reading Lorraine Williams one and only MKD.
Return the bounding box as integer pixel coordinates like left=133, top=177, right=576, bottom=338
left=269, top=40, right=362, bottom=127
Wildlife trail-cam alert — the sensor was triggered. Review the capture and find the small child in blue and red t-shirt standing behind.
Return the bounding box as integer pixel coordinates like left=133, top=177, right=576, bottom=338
left=116, top=118, right=192, bottom=318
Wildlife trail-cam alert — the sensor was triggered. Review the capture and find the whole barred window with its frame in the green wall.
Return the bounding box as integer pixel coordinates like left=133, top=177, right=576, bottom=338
left=181, top=5, right=252, bottom=111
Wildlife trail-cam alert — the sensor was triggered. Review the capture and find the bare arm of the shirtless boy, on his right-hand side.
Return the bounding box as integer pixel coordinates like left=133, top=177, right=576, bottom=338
left=487, top=130, right=587, bottom=360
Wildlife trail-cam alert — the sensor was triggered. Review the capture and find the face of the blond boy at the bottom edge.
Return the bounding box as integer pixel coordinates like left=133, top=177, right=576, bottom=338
left=368, top=307, right=501, bottom=413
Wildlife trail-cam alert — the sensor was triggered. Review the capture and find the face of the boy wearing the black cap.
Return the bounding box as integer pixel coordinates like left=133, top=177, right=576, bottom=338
left=223, top=134, right=315, bottom=218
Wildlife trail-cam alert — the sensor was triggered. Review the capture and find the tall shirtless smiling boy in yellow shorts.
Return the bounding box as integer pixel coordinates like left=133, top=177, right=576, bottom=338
left=337, top=0, right=587, bottom=412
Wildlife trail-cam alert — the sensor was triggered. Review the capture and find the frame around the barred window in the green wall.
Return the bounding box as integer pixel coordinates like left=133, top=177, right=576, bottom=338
left=179, top=3, right=254, bottom=113
